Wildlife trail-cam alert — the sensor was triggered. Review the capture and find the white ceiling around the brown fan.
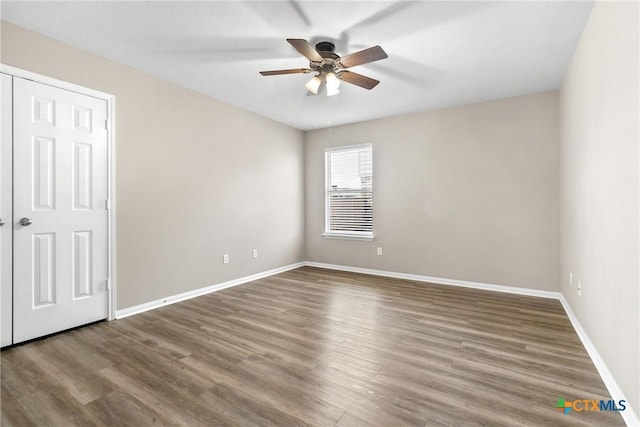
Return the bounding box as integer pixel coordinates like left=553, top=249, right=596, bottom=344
left=1, top=0, right=593, bottom=130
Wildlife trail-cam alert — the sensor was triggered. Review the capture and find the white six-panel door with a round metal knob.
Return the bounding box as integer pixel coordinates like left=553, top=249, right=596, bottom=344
left=13, top=78, right=108, bottom=343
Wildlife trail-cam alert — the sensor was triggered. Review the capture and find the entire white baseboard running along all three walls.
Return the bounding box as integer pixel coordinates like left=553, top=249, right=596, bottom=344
left=111, top=261, right=640, bottom=427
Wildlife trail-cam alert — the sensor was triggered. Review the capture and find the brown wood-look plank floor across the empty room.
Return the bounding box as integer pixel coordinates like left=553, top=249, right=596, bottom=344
left=0, top=267, right=624, bottom=427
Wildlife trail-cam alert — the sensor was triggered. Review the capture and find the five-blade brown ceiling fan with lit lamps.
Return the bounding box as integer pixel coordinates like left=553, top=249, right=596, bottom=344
left=260, top=39, right=387, bottom=96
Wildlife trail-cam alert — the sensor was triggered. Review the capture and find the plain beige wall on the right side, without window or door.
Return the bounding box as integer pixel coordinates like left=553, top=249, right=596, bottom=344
left=560, top=2, right=640, bottom=413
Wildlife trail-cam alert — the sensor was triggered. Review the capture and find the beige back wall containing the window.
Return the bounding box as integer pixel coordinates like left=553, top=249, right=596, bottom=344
left=305, top=92, right=559, bottom=291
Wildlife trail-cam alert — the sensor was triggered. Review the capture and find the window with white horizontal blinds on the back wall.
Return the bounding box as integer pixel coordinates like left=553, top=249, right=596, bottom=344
left=323, top=145, right=373, bottom=240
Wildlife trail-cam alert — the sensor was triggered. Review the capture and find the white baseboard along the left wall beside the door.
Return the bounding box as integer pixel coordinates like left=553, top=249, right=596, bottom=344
left=116, top=262, right=305, bottom=319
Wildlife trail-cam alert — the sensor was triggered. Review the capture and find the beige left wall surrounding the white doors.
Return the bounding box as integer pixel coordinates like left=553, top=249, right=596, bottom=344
left=0, top=22, right=304, bottom=309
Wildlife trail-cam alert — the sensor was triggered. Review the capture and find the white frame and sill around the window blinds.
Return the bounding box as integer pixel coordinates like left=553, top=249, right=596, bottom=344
left=322, top=143, right=375, bottom=241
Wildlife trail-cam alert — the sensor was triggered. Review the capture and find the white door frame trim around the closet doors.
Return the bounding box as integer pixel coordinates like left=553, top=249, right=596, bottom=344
left=0, top=63, right=116, bottom=320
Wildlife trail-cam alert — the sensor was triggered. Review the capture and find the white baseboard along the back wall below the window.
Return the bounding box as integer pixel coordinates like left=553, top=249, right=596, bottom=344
left=305, top=261, right=561, bottom=299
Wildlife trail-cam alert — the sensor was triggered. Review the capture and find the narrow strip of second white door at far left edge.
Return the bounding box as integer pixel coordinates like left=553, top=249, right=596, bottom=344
left=0, top=74, right=13, bottom=347
